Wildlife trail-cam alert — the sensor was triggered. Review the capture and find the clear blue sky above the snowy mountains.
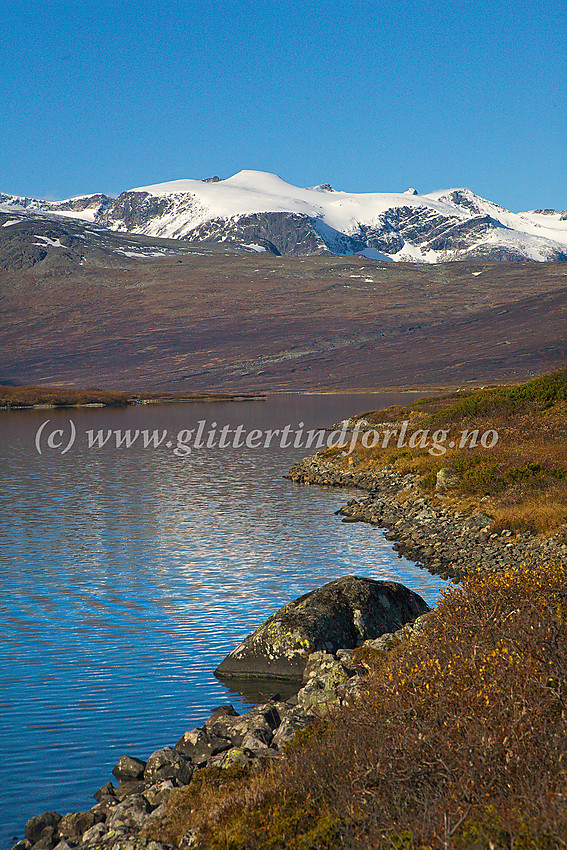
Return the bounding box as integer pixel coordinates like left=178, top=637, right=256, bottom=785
left=0, top=0, right=567, bottom=211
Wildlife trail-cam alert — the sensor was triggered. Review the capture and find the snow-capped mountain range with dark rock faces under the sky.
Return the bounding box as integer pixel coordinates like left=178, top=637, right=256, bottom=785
left=0, top=171, right=567, bottom=263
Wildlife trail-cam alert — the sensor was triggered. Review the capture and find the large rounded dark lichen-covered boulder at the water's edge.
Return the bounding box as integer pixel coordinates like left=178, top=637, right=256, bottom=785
left=215, top=576, right=429, bottom=680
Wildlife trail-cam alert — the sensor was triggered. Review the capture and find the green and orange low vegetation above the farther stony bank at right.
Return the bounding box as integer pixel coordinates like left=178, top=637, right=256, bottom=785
left=327, top=369, right=567, bottom=534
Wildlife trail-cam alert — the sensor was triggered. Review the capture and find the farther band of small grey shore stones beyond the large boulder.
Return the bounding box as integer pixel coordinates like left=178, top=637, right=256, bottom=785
left=287, top=454, right=567, bottom=580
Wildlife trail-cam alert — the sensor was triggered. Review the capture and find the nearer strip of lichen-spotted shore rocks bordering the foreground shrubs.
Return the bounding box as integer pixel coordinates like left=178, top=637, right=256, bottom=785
left=12, top=612, right=429, bottom=850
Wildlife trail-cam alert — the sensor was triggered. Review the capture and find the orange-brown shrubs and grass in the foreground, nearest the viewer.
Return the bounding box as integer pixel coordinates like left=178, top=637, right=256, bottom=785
left=144, top=563, right=567, bottom=850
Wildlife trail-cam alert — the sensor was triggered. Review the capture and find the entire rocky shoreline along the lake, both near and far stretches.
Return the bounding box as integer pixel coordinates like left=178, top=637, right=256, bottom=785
left=12, top=454, right=567, bottom=850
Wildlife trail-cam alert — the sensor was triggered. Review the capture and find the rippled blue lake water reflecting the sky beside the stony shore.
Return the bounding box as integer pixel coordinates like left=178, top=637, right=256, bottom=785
left=0, top=393, right=444, bottom=848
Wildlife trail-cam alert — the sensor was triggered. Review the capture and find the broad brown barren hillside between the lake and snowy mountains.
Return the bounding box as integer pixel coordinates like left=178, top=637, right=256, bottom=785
left=0, top=214, right=567, bottom=391
